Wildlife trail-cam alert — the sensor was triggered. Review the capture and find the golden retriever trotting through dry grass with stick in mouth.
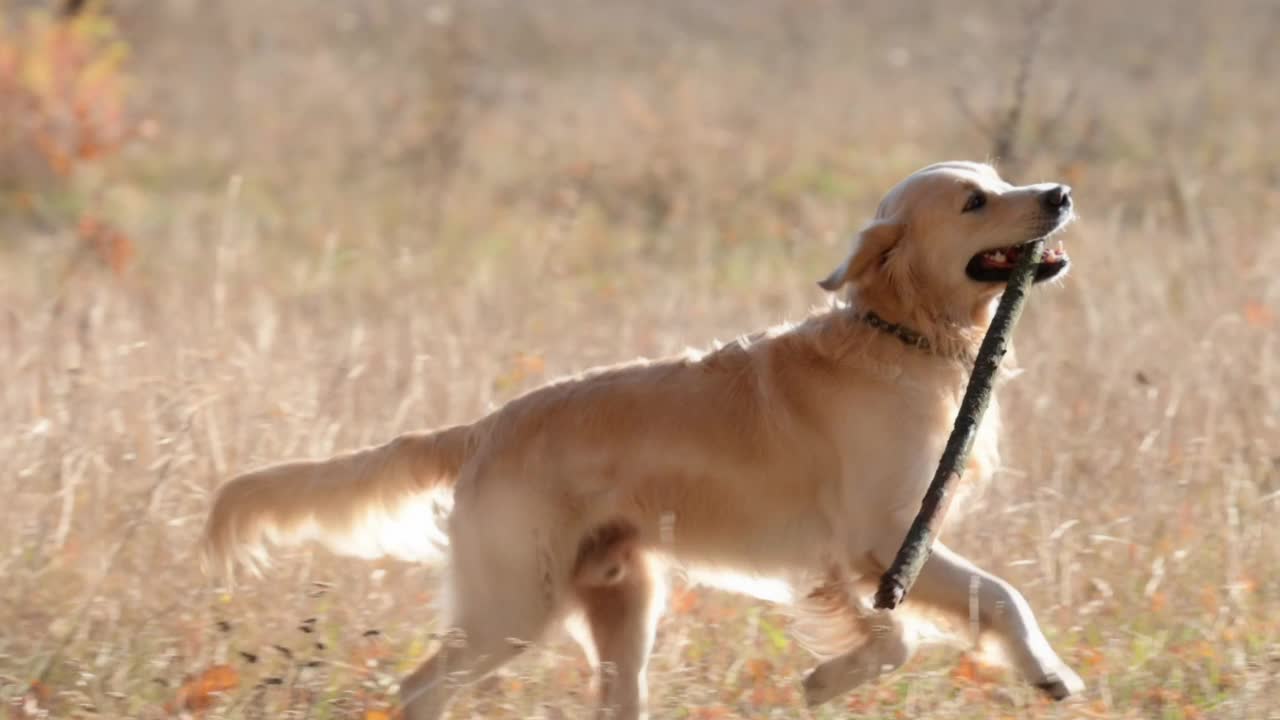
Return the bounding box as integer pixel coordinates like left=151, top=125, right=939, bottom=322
left=205, top=161, right=1083, bottom=720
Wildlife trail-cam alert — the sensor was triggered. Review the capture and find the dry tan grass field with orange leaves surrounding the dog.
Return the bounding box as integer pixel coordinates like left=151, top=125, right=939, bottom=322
left=0, top=0, right=1280, bottom=720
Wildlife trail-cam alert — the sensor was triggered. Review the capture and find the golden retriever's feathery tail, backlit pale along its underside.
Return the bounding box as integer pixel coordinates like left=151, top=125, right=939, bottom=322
left=204, top=425, right=475, bottom=573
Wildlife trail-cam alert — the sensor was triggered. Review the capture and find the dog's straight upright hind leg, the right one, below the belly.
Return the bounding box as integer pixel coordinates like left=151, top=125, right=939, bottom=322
left=571, top=552, right=666, bottom=720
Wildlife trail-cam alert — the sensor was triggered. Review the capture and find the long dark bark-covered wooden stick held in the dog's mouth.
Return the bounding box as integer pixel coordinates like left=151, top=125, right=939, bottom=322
left=876, top=238, right=1044, bottom=610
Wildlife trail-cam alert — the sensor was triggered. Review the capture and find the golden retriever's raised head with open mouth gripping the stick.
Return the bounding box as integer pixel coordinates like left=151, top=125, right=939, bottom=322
left=818, top=161, right=1075, bottom=324
